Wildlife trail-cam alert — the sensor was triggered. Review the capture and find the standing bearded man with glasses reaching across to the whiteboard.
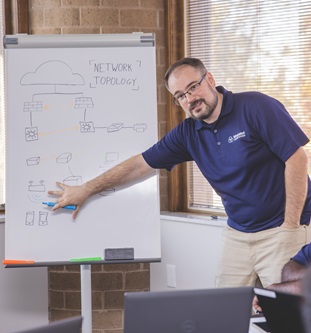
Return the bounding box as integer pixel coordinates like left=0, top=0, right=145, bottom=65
left=49, top=58, right=311, bottom=287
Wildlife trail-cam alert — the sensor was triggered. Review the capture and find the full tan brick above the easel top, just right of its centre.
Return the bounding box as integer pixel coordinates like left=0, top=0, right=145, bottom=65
left=81, top=7, right=119, bottom=26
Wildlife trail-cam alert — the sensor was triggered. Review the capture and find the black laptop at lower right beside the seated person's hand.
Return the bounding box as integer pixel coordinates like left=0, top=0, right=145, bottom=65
left=252, top=288, right=305, bottom=333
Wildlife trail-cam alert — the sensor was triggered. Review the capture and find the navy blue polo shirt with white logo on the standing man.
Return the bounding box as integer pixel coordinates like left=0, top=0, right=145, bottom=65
left=143, top=86, right=311, bottom=232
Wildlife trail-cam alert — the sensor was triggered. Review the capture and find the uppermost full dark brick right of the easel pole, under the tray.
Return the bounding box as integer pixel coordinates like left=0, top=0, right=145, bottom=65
left=92, top=273, right=123, bottom=291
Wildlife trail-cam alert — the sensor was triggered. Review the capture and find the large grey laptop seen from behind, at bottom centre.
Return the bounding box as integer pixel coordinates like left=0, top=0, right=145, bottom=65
left=124, top=287, right=254, bottom=333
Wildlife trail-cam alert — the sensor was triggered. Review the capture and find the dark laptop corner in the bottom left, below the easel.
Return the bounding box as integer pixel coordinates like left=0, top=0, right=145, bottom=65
left=12, top=317, right=82, bottom=333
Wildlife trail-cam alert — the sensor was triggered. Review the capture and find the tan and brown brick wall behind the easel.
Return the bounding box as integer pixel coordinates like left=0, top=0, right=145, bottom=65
left=29, top=0, right=168, bottom=333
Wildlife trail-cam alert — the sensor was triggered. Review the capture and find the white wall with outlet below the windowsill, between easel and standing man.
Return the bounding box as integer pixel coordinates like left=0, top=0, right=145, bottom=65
left=150, top=212, right=226, bottom=291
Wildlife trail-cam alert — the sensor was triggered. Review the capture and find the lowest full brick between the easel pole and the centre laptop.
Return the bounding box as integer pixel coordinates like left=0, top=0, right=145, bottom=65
left=92, top=310, right=123, bottom=330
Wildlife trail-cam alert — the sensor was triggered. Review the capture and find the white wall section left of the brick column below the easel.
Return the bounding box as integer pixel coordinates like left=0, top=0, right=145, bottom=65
left=0, top=217, right=48, bottom=333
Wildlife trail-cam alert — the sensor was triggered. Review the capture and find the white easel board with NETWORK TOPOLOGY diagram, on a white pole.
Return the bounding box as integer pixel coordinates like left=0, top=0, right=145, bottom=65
left=4, top=33, right=161, bottom=333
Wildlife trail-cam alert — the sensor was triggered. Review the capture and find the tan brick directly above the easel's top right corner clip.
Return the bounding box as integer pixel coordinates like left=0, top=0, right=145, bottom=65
left=120, top=9, right=157, bottom=28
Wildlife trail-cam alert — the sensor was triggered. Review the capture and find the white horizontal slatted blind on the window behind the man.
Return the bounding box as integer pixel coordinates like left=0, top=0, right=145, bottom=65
left=185, top=0, right=311, bottom=212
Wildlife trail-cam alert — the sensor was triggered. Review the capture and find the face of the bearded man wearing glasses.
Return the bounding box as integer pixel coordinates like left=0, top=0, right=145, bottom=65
left=168, top=65, right=218, bottom=122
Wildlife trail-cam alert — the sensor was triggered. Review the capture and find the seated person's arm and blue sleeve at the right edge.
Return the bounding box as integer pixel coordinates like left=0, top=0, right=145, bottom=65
left=253, top=243, right=311, bottom=312
